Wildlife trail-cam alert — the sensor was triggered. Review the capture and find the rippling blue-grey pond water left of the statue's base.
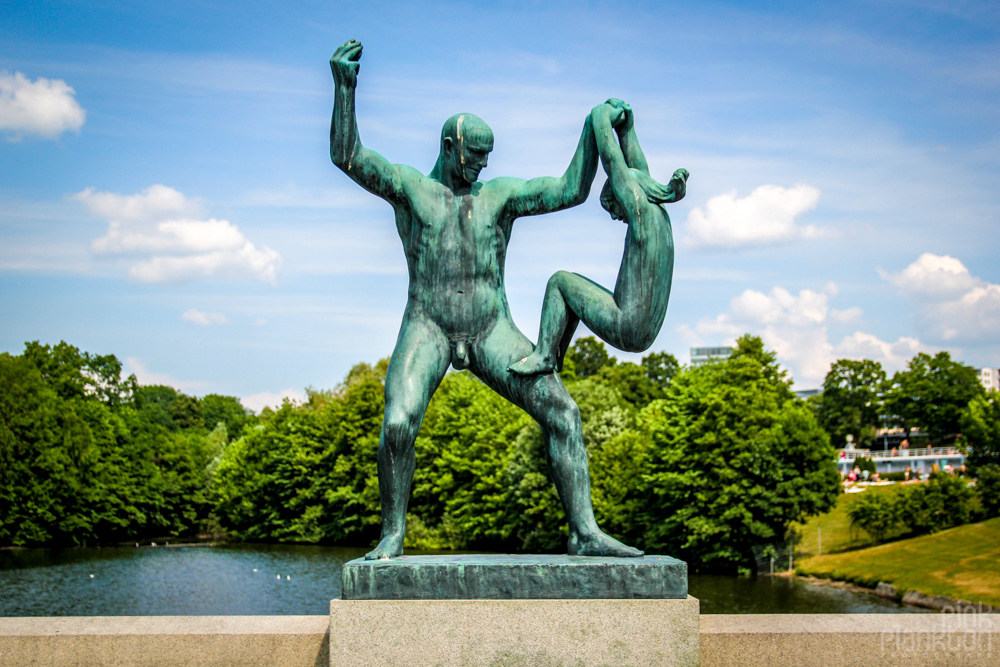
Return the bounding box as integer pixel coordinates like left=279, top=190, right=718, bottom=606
left=0, top=544, right=365, bottom=616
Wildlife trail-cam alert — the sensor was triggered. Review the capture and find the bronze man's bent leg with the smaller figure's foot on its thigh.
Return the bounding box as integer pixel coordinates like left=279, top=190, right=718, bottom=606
left=470, top=319, right=642, bottom=557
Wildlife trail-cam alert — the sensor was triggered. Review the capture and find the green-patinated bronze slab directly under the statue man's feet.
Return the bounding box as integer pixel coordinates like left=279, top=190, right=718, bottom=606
left=341, top=554, right=687, bottom=600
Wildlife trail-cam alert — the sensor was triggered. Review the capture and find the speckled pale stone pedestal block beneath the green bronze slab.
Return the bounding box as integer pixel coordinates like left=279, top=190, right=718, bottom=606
left=330, top=596, right=699, bottom=666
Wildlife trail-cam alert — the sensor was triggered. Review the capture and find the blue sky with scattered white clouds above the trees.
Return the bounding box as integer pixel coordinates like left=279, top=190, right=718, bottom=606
left=0, top=0, right=1000, bottom=410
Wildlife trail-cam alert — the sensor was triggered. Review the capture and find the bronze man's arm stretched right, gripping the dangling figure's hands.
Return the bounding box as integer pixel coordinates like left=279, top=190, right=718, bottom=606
left=507, top=116, right=597, bottom=218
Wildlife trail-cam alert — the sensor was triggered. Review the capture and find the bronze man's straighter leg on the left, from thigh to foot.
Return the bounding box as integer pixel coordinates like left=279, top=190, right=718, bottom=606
left=365, top=315, right=450, bottom=560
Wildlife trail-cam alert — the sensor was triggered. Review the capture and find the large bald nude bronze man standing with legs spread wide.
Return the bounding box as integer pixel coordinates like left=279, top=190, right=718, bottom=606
left=330, top=40, right=642, bottom=559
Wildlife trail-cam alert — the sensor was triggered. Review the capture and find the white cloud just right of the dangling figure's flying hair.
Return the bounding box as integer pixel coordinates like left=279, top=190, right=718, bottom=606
left=682, top=184, right=828, bottom=248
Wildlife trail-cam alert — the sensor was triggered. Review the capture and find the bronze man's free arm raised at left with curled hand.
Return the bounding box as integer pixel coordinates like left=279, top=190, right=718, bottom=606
left=330, top=39, right=402, bottom=202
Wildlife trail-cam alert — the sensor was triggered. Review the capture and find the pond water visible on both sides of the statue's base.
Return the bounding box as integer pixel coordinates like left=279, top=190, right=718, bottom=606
left=0, top=544, right=922, bottom=616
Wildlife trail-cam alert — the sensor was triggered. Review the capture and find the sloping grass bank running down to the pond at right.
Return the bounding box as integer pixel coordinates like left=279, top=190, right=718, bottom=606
left=796, top=516, right=1000, bottom=605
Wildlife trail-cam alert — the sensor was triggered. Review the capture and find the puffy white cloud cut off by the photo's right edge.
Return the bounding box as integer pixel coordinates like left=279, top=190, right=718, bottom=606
left=880, top=253, right=1000, bottom=344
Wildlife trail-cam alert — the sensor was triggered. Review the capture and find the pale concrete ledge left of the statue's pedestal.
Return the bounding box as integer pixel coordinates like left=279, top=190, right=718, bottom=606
left=0, top=616, right=330, bottom=667
